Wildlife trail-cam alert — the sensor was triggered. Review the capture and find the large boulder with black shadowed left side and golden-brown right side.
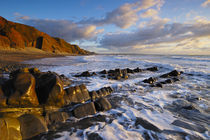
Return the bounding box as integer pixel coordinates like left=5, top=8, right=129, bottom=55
left=36, top=73, right=65, bottom=107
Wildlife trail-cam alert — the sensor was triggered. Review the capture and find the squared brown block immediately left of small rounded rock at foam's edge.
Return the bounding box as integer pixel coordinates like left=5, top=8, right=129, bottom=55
left=73, top=102, right=96, bottom=118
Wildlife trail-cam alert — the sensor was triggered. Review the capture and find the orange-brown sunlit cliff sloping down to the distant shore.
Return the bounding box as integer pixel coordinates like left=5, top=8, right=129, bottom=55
left=0, top=16, right=90, bottom=54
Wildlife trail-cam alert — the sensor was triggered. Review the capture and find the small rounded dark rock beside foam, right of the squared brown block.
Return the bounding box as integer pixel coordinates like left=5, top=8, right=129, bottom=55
left=94, top=98, right=112, bottom=111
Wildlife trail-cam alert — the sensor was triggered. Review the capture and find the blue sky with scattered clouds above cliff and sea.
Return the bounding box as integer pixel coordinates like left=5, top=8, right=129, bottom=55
left=0, top=0, right=210, bottom=55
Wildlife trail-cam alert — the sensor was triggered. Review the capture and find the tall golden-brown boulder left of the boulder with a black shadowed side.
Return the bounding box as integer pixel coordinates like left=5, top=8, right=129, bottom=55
left=8, top=73, right=39, bottom=107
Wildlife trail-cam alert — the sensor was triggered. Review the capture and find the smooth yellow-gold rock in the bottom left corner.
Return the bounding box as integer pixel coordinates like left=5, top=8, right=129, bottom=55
left=0, top=117, right=22, bottom=140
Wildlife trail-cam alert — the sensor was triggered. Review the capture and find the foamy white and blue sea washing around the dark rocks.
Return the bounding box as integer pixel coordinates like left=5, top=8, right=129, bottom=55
left=24, top=55, right=210, bottom=140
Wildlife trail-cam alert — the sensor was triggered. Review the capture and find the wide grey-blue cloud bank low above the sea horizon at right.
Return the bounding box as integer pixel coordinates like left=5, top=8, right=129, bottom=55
left=100, top=18, right=210, bottom=52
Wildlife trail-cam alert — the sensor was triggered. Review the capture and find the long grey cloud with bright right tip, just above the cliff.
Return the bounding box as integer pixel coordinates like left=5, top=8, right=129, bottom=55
left=16, top=14, right=103, bottom=42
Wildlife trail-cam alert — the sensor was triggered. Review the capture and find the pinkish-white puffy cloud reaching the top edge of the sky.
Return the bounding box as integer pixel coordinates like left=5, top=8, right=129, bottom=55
left=78, top=0, right=164, bottom=29
